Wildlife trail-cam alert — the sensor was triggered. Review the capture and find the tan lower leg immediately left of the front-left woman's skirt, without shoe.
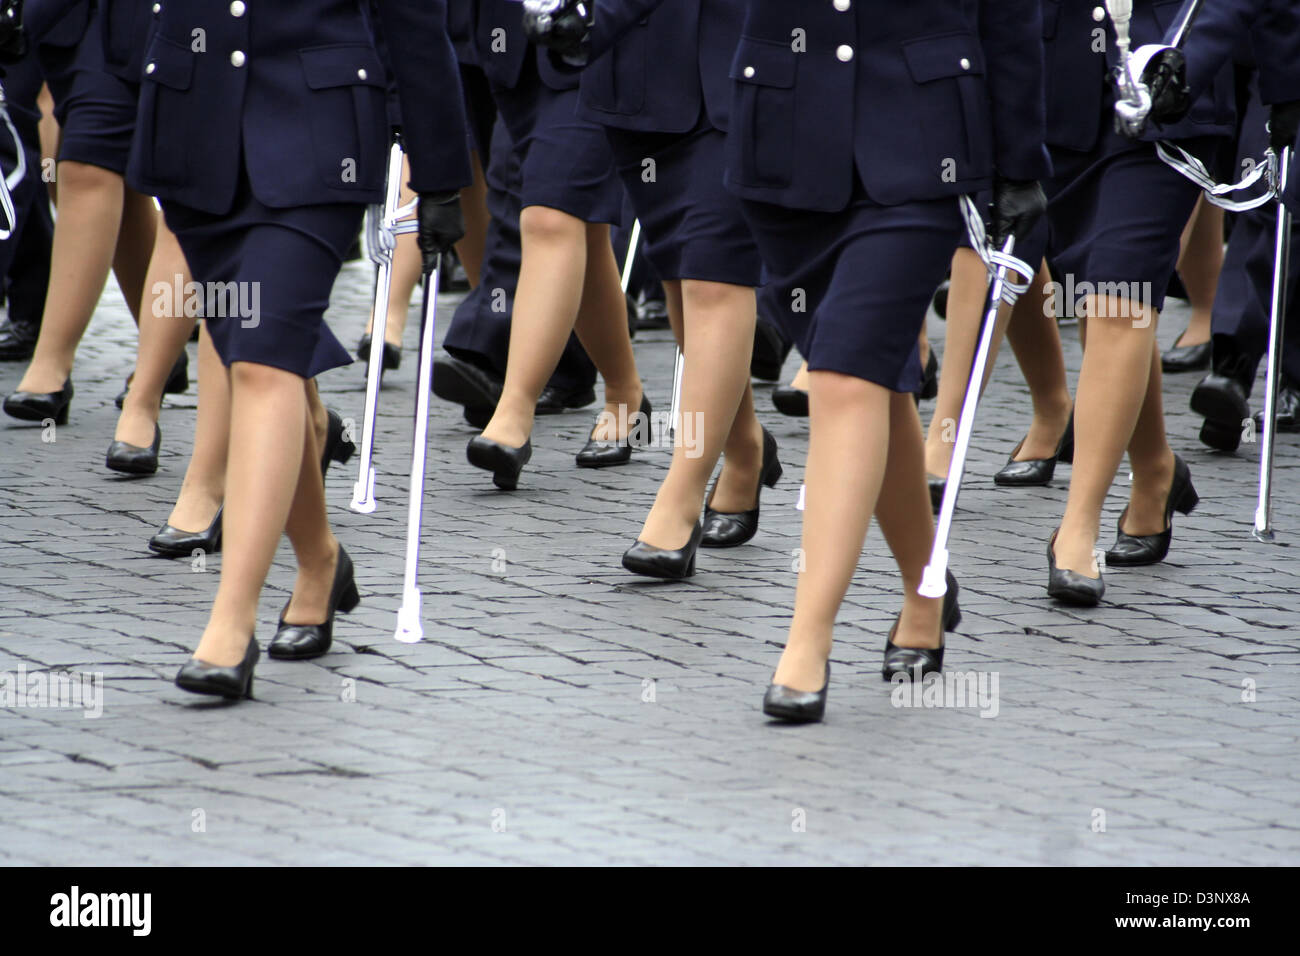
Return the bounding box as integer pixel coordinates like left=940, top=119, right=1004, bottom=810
left=113, top=221, right=195, bottom=447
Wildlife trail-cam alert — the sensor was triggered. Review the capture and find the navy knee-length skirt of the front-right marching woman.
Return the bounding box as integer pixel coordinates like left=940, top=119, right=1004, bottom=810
left=742, top=181, right=966, bottom=392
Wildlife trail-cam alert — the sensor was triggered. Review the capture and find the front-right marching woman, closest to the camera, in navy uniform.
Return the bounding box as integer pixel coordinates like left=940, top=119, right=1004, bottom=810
left=727, top=0, right=1048, bottom=722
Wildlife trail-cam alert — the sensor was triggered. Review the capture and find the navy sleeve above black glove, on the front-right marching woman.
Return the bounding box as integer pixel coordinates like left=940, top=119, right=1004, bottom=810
left=979, top=0, right=1050, bottom=179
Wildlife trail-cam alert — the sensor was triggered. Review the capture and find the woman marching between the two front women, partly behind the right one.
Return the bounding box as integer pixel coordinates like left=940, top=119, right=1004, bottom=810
left=525, top=0, right=781, bottom=579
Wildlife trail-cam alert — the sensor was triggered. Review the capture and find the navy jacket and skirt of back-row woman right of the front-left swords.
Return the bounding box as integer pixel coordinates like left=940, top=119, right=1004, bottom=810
left=475, top=0, right=623, bottom=222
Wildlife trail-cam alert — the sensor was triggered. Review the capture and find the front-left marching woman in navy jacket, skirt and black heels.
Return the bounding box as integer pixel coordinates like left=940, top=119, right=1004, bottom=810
left=129, top=0, right=469, bottom=698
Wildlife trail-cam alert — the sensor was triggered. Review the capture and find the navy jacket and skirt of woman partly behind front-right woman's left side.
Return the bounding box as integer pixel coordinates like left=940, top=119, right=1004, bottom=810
left=579, top=0, right=762, bottom=286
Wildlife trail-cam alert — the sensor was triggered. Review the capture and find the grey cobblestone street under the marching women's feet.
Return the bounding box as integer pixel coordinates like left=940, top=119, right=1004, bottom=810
left=0, top=269, right=1300, bottom=865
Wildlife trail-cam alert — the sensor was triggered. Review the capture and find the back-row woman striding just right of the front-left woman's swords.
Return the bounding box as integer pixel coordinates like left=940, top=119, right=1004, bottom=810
left=467, top=0, right=650, bottom=490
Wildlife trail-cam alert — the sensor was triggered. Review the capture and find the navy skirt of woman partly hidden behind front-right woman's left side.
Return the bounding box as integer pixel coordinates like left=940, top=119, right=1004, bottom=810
left=606, top=116, right=763, bottom=286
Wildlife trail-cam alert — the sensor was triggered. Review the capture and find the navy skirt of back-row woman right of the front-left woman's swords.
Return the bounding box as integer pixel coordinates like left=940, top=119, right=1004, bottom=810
left=491, top=56, right=623, bottom=224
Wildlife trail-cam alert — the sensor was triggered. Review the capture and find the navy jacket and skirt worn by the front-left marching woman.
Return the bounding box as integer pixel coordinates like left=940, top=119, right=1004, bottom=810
left=129, top=0, right=469, bottom=377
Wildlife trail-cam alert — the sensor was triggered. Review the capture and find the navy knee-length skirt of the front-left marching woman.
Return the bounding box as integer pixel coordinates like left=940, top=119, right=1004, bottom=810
left=163, top=176, right=365, bottom=378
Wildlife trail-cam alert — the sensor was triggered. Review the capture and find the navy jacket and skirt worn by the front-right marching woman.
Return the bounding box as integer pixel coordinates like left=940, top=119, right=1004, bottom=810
left=727, top=0, right=1048, bottom=392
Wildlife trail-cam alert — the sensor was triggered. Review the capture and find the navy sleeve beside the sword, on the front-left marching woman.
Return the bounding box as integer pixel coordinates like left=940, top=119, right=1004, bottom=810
left=374, top=0, right=472, bottom=193
